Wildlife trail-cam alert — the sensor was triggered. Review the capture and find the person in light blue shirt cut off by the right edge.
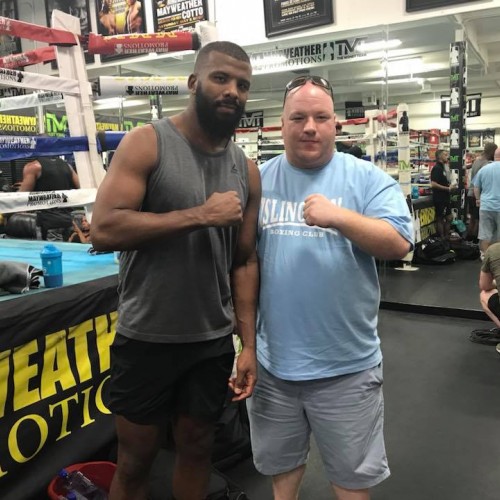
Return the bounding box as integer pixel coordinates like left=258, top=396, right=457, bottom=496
left=472, top=148, right=500, bottom=256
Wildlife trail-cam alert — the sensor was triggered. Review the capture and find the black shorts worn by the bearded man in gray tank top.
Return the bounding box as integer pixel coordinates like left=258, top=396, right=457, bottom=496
left=106, top=333, right=234, bottom=425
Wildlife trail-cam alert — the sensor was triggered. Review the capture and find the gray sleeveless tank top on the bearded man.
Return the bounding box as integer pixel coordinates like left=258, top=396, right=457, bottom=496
left=117, top=118, right=248, bottom=343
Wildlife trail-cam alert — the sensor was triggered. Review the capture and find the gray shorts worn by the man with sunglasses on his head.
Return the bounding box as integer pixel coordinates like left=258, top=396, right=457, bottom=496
left=247, top=365, right=390, bottom=489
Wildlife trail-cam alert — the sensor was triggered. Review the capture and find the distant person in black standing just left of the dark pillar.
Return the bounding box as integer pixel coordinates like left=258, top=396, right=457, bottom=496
left=431, top=149, right=453, bottom=239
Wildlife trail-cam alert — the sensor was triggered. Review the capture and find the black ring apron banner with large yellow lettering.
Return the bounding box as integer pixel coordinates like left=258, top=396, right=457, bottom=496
left=0, top=276, right=117, bottom=500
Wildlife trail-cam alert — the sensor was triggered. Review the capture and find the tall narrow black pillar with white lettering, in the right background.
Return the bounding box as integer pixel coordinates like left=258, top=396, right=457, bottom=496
left=450, top=42, right=467, bottom=218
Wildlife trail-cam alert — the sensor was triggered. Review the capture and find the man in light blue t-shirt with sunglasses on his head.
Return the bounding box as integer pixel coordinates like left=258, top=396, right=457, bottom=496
left=248, top=76, right=413, bottom=500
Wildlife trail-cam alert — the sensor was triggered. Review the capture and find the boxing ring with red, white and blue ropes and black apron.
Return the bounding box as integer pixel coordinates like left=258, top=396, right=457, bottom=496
left=0, top=10, right=215, bottom=500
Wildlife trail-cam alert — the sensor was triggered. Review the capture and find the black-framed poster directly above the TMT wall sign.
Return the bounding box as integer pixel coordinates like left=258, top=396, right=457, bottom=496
left=264, top=0, right=333, bottom=38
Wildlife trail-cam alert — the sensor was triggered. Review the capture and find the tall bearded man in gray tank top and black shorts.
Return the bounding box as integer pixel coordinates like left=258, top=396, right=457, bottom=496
left=91, top=42, right=261, bottom=500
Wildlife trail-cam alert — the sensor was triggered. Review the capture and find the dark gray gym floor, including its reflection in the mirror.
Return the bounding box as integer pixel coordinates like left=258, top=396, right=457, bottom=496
left=226, top=260, right=500, bottom=500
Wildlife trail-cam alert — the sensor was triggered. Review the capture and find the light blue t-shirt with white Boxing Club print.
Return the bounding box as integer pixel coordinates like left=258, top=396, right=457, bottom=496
left=257, top=152, right=413, bottom=380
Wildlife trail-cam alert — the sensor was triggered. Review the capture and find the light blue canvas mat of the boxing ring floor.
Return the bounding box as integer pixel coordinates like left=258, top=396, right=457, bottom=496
left=0, top=239, right=118, bottom=301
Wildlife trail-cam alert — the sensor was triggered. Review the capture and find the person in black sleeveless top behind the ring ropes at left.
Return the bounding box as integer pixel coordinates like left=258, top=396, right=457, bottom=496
left=19, top=157, right=80, bottom=241
